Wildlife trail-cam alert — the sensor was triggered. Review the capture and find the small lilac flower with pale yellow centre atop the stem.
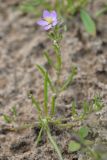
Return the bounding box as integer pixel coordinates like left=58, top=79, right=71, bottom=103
left=37, top=10, right=58, bottom=30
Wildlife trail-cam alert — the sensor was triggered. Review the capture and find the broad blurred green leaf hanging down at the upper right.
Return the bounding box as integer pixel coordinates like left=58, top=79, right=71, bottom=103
left=80, top=9, right=96, bottom=35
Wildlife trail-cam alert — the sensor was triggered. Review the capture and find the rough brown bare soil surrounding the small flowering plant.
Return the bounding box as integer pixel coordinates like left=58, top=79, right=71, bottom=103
left=0, top=0, right=107, bottom=160
